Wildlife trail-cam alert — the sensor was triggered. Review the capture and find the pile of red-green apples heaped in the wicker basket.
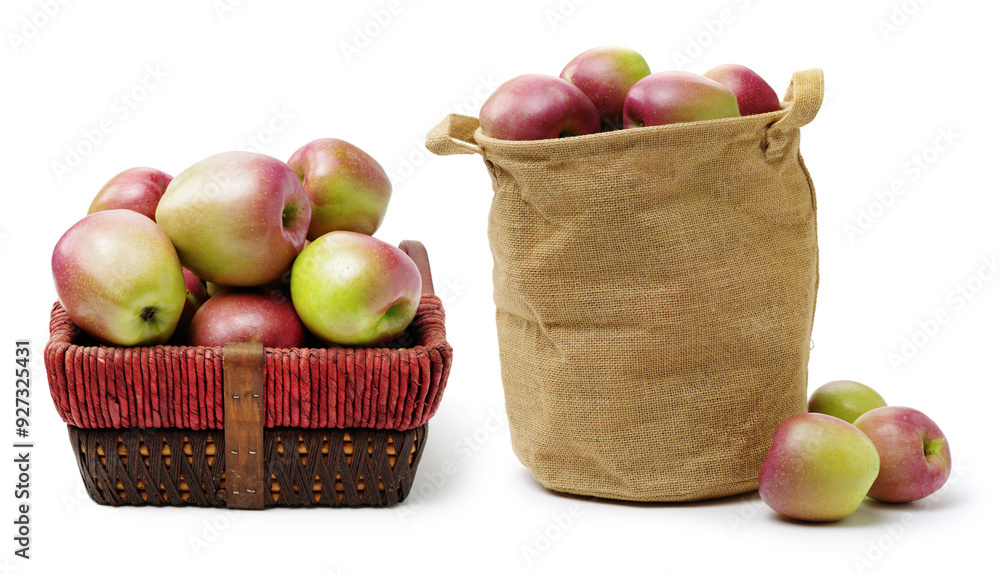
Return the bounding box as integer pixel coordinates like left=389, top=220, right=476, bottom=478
left=52, top=139, right=421, bottom=354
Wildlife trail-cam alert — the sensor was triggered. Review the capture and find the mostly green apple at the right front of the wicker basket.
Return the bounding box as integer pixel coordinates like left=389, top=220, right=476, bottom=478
left=292, top=231, right=421, bottom=346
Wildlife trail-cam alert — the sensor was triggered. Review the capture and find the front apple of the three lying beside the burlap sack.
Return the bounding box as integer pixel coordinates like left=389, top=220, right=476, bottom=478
left=758, top=413, right=879, bottom=522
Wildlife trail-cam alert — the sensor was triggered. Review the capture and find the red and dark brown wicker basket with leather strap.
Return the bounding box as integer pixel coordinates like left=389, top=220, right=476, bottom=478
left=45, top=241, right=452, bottom=509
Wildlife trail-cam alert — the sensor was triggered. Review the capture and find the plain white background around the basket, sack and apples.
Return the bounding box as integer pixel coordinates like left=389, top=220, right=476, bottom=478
left=0, top=0, right=1000, bottom=574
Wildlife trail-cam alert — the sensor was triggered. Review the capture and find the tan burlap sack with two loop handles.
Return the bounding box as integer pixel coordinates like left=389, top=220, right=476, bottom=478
left=427, top=69, right=823, bottom=501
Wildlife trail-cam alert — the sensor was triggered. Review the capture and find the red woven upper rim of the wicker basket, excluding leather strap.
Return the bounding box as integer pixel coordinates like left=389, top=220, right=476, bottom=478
left=45, top=293, right=452, bottom=430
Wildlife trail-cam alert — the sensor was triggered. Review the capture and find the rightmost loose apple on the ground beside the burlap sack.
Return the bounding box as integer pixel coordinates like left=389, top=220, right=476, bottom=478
left=854, top=407, right=951, bottom=502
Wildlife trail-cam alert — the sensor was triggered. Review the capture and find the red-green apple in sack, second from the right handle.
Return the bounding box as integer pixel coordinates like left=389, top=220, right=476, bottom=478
left=622, top=71, right=740, bottom=128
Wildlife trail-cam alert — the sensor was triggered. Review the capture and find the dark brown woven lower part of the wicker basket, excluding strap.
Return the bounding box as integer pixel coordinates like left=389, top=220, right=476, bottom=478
left=69, top=425, right=427, bottom=507
